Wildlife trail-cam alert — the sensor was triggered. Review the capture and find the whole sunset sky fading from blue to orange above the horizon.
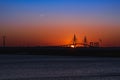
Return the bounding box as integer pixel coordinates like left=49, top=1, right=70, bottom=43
left=0, top=0, right=120, bottom=47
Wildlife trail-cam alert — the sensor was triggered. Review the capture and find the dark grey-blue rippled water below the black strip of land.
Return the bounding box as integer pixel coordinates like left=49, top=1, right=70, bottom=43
left=0, top=55, right=120, bottom=80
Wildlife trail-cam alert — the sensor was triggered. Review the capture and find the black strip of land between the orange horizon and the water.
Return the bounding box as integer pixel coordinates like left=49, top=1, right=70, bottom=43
left=0, top=47, right=120, bottom=57
